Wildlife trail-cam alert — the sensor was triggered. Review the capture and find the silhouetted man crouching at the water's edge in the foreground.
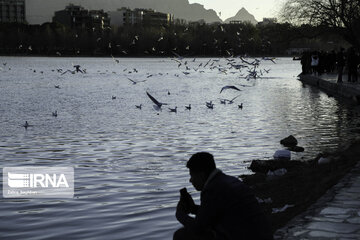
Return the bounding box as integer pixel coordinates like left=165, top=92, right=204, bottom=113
left=173, top=152, right=273, bottom=240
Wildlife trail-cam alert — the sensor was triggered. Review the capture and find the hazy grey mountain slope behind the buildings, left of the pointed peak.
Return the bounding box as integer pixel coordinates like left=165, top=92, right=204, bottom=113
left=25, top=0, right=222, bottom=24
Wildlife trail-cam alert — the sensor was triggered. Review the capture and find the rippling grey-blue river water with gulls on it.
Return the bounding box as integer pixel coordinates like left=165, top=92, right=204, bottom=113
left=0, top=57, right=359, bottom=240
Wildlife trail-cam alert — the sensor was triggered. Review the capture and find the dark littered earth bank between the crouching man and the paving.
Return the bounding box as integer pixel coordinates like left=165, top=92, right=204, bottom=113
left=239, top=139, right=360, bottom=232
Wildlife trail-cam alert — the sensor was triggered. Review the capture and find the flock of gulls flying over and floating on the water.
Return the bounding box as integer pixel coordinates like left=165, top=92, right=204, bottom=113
left=3, top=52, right=275, bottom=129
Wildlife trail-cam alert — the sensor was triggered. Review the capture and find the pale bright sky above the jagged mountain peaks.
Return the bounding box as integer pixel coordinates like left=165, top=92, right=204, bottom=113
left=189, top=0, right=284, bottom=21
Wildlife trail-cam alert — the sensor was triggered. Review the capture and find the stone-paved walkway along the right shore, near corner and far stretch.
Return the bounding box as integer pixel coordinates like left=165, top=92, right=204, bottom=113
left=274, top=74, right=360, bottom=240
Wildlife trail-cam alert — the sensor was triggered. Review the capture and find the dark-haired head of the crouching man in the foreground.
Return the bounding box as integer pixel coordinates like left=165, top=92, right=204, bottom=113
left=186, top=152, right=216, bottom=191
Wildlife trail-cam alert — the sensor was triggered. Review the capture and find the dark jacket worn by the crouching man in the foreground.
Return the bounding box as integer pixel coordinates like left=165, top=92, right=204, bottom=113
left=177, top=170, right=273, bottom=240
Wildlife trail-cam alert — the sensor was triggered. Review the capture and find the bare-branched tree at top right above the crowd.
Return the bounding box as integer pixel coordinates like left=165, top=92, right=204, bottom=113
left=280, top=0, right=360, bottom=47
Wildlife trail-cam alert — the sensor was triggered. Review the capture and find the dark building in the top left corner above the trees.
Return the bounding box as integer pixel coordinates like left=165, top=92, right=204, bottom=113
left=0, top=0, right=25, bottom=23
